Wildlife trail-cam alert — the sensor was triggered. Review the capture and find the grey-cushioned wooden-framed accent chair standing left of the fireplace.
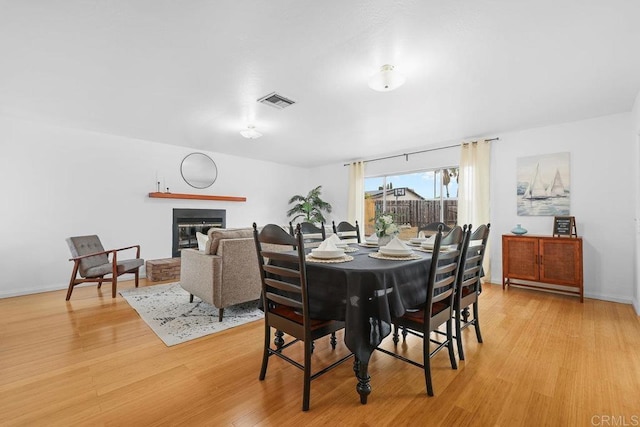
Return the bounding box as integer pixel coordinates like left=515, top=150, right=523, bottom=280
left=66, top=235, right=144, bottom=301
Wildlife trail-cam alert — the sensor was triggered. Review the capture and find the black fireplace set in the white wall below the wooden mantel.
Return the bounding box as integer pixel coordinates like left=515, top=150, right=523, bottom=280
left=171, top=209, right=227, bottom=258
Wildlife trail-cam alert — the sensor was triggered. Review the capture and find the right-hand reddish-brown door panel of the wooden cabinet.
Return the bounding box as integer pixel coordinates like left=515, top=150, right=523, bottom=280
left=540, top=238, right=582, bottom=287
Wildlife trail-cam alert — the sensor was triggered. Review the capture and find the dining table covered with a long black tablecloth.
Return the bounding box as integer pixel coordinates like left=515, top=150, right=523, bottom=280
left=306, top=244, right=431, bottom=404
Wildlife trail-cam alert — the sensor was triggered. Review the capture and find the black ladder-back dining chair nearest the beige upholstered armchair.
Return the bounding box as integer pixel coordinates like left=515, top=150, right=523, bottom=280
left=253, top=223, right=353, bottom=411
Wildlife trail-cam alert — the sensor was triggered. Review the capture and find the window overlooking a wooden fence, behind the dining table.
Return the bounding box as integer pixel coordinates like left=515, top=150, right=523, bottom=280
left=364, top=166, right=458, bottom=238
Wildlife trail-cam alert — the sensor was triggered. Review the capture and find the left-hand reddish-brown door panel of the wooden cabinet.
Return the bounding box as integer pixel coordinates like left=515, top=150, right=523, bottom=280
left=502, top=236, right=539, bottom=280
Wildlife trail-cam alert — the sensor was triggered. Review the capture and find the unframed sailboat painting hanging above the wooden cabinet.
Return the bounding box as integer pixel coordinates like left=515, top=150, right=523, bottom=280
left=517, top=153, right=571, bottom=216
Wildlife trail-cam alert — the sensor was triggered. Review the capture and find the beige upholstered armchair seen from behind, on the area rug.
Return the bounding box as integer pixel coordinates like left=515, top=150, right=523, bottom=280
left=180, top=228, right=261, bottom=321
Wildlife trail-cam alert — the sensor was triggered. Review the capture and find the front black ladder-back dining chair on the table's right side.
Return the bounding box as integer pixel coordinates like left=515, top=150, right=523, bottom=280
left=376, top=227, right=468, bottom=396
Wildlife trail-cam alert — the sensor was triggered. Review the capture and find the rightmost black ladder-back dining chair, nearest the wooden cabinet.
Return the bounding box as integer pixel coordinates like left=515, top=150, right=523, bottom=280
left=455, top=224, right=491, bottom=360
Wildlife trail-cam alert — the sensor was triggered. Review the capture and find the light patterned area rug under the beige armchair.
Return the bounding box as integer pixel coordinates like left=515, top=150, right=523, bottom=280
left=120, top=283, right=263, bottom=346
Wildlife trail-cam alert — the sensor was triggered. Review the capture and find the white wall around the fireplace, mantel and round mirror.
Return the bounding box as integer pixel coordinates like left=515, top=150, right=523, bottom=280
left=0, top=117, right=308, bottom=297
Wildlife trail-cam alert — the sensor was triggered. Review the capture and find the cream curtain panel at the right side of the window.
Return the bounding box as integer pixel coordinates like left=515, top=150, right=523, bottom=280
left=458, top=140, right=491, bottom=281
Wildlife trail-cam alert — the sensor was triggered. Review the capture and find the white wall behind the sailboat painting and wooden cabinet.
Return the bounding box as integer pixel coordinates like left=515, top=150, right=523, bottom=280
left=491, top=113, right=637, bottom=303
